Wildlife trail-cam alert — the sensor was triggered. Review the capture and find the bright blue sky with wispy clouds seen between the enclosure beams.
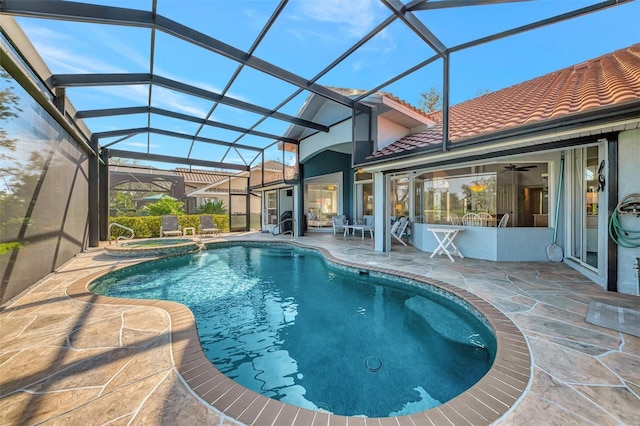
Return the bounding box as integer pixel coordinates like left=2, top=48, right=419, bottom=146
left=10, top=0, right=640, bottom=167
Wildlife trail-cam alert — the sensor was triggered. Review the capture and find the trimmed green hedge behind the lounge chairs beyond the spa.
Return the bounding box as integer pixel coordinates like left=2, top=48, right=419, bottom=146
left=109, top=214, right=229, bottom=240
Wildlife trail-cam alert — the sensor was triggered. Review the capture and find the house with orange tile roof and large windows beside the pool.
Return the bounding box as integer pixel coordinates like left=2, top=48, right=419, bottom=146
left=294, top=44, right=640, bottom=294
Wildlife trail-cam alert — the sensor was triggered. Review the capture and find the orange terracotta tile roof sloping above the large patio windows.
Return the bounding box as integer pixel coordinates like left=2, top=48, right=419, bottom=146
left=367, top=43, right=640, bottom=160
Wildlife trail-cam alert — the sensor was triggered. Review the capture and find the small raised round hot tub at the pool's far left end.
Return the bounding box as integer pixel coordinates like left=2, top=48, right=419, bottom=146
left=105, top=238, right=200, bottom=257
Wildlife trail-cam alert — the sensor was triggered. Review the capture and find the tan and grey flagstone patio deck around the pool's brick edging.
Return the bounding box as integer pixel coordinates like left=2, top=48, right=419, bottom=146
left=0, top=233, right=640, bottom=426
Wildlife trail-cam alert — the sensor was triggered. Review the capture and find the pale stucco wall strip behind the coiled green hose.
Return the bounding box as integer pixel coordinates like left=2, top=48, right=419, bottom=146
left=612, top=130, right=640, bottom=295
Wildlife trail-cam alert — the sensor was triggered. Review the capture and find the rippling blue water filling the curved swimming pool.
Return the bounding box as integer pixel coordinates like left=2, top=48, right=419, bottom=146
left=92, top=245, right=495, bottom=417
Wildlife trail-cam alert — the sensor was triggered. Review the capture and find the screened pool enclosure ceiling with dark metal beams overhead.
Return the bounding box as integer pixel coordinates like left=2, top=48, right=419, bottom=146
left=0, top=0, right=638, bottom=170
